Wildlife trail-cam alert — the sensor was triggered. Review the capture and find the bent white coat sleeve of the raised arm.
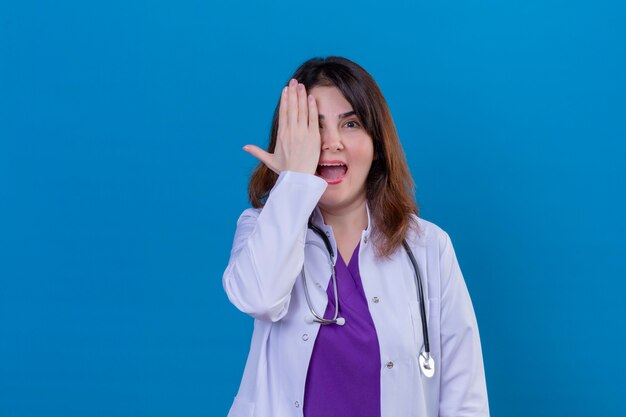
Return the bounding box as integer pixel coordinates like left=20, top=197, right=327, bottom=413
left=222, top=171, right=327, bottom=321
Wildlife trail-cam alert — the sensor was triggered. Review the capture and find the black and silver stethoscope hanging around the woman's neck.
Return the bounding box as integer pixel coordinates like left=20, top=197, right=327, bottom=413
left=302, top=221, right=435, bottom=378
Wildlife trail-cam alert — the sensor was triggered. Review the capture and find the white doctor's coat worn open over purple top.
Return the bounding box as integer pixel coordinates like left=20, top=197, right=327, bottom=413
left=223, top=171, right=489, bottom=417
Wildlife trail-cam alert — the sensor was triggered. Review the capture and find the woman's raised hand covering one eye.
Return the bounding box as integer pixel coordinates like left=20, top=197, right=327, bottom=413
left=243, top=79, right=322, bottom=174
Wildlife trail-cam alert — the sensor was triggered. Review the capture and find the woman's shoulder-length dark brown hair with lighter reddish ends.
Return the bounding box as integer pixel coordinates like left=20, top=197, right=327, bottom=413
left=248, top=56, right=418, bottom=257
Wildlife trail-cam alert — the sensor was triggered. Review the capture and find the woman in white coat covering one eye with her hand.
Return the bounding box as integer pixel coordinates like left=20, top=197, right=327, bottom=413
left=223, top=57, right=489, bottom=417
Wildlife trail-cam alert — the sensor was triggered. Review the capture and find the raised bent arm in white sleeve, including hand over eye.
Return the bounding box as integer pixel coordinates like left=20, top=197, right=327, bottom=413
left=222, top=79, right=327, bottom=321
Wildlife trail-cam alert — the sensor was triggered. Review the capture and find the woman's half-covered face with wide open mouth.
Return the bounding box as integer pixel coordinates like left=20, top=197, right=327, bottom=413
left=310, top=86, right=374, bottom=212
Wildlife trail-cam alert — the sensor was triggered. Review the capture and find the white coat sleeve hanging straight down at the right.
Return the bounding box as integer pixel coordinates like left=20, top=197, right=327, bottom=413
left=439, top=232, right=489, bottom=417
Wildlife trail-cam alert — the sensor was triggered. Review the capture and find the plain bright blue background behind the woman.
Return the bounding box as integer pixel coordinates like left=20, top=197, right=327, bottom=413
left=0, top=0, right=626, bottom=417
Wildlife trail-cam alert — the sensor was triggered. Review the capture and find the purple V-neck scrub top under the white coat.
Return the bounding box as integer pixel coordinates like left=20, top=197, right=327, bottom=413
left=304, top=244, right=380, bottom=417
